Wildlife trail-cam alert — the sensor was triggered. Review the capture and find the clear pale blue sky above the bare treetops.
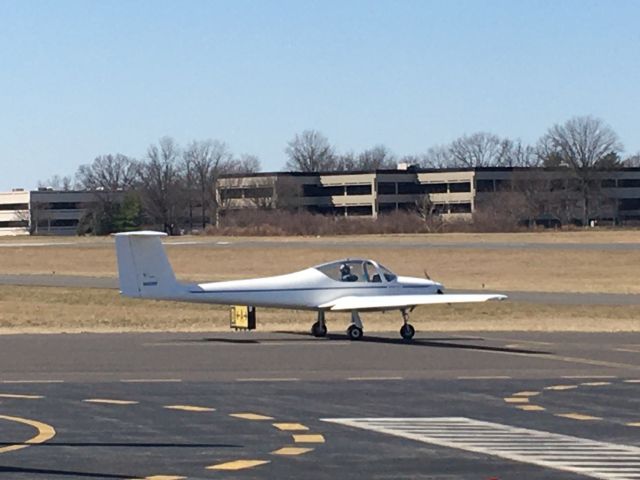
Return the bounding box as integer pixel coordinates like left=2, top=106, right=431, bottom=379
left=0, top=0, right=640, bottom=190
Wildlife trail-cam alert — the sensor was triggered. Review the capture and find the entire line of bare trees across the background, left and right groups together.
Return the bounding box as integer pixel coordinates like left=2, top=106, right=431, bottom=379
left=40, top=116, right=640, bottom=233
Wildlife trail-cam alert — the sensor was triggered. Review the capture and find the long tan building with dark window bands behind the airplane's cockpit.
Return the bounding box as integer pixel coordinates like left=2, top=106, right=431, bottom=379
left=217, top=167, right=640, bottom=224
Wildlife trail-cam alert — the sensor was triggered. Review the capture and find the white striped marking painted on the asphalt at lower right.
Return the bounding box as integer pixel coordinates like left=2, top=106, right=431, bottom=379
left=322, top=417, right=640, bottom=480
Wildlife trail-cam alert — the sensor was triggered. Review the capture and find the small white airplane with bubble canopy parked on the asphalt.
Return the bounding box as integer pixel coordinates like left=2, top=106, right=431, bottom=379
left=114, top=231, right=506, bottom=340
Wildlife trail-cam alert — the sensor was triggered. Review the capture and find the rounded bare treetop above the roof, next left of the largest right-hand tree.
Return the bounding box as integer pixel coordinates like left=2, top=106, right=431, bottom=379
left=449, top=132, right=510, bottom=168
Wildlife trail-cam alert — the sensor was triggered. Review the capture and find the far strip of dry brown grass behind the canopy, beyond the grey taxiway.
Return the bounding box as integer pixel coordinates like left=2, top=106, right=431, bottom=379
left=0, top=239, right=640, bottom=294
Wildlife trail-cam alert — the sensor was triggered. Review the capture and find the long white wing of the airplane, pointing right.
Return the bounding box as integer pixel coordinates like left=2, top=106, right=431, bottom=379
left=319, top=293, right=507, bottom=311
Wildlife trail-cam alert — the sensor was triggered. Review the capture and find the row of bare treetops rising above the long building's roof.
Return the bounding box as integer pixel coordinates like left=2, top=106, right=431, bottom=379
left=285, top=116, right=640, bottom=172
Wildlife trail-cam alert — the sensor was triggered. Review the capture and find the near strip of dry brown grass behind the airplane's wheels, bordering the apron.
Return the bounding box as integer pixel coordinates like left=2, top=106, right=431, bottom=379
left=0, top=286, right=640, bottom=333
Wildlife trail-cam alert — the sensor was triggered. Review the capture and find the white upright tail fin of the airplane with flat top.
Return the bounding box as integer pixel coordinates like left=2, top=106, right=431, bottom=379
left=114, top=231, right=180, bottom=298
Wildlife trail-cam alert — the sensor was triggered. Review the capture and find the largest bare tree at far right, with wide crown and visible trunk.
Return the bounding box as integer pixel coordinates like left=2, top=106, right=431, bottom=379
left=538, top=116, right=622, bottom=225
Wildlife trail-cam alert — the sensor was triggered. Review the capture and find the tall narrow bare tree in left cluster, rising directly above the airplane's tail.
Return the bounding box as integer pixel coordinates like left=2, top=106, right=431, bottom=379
left=141, top=137, right=182, bottom=234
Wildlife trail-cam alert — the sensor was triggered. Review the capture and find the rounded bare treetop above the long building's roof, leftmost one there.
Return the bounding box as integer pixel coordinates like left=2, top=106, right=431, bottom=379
left=285, top=130, right=336, bottom=172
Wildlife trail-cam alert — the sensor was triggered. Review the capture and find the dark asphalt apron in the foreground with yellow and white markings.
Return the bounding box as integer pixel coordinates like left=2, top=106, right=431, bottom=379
left=0, top=332, right=640, bottom=480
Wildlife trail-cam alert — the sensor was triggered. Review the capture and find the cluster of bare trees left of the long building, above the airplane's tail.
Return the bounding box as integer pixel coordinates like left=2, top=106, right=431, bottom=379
left=39, top=137, right=260, bottom=234
